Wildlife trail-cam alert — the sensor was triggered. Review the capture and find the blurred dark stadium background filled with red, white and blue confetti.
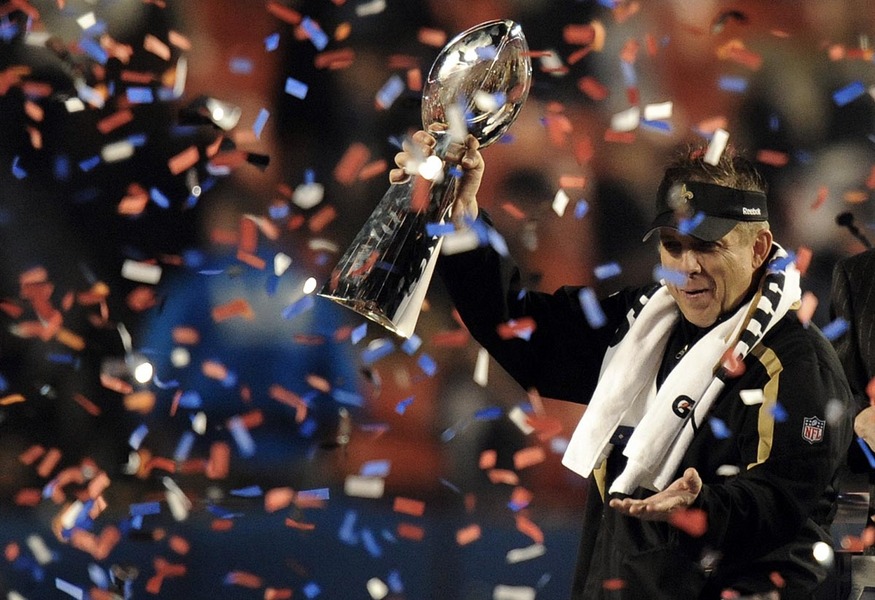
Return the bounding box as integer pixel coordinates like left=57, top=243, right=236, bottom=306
left=0, top=0, right=875, bottom=600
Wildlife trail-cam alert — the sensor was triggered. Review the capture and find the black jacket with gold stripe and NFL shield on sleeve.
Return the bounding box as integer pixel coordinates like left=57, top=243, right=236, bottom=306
left=438, top=237, right=851, bottom=600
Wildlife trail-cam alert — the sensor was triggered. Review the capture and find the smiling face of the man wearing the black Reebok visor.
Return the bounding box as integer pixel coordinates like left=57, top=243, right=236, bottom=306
left=659, top=227, right=762, bottom=327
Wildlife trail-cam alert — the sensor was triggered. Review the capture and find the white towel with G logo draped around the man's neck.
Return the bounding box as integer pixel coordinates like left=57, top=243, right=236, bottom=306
left=562, top=244, right=801, bottom=494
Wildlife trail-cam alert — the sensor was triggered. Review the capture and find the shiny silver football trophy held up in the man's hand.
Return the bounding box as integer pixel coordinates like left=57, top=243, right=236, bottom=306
left=319, top=20, right=532, bottom=338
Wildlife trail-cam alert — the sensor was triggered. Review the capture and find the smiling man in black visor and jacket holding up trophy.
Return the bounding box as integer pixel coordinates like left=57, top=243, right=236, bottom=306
left=390, top=132, right=851, bottom=600
